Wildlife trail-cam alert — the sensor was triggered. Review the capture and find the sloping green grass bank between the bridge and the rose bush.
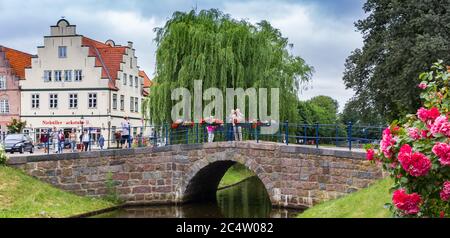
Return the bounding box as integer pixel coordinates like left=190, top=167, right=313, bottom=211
left=298, top=179, right=393, bottom=218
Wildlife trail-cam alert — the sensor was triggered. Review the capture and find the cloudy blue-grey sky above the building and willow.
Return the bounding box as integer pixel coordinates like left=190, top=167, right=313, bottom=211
left=0, top=0, right=365, bottom=109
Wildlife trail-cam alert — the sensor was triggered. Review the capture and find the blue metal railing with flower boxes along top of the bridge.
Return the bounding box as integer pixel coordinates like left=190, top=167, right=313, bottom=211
left=28, top=122, right=385, bottom=153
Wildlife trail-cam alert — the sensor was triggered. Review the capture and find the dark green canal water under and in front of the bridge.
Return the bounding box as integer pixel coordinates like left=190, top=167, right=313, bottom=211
left=94, top=177, right=302, bottom=218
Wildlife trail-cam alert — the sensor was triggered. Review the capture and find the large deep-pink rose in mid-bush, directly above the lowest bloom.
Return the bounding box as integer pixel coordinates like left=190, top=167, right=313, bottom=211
left=398, top=144, right=431, bottom=177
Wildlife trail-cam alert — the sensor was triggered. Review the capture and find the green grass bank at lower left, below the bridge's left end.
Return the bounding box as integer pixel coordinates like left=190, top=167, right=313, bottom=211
left=0, top=166, right=116, bottom=218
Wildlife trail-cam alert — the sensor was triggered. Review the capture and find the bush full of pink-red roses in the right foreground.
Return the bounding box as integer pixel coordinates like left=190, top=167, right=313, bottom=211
left=366, top=61, right=450, bottom=217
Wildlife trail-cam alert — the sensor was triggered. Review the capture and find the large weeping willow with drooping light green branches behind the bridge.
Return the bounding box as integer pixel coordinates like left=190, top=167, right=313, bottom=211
left=143, top=9, right=313, bottom=123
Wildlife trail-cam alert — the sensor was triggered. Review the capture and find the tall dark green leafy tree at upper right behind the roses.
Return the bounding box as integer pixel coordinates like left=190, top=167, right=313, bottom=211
left=344, top=0, right=450, bottom=123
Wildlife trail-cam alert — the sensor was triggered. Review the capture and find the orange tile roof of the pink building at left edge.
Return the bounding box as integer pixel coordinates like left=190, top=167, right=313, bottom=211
left=0, top=46, right=32, bottom=80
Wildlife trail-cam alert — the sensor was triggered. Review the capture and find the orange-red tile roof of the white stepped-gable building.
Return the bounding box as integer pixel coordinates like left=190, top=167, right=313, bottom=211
left=82, top=37, right=127, bottom=90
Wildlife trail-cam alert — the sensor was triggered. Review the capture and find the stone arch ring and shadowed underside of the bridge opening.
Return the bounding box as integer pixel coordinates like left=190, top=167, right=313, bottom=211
left=177, top=150, right=274, bottom=203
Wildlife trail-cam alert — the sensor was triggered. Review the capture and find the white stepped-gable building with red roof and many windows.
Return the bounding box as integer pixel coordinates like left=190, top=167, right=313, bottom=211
left=20, top=19, right=149, bottom=142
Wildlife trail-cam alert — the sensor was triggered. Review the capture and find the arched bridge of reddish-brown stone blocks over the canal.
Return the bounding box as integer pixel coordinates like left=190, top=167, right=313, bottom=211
left=8, top=142, right=382, bottom=207
